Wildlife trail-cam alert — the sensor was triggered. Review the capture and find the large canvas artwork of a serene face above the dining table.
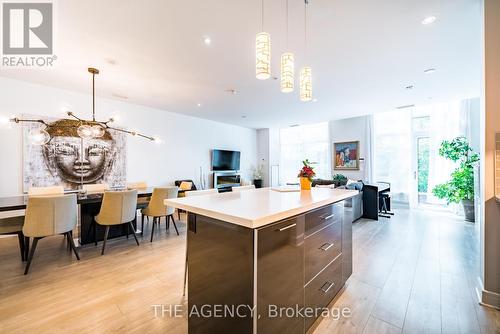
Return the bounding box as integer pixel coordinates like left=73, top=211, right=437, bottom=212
left=23, top=116, right=127, bottom=192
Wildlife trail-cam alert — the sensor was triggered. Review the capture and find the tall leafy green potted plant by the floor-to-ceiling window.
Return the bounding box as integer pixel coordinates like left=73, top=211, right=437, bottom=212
left=432, top=137, right=479, bottom=222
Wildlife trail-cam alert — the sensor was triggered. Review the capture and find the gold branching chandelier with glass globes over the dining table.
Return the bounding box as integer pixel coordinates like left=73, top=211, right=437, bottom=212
left=10, top=67, right=161, bottom=145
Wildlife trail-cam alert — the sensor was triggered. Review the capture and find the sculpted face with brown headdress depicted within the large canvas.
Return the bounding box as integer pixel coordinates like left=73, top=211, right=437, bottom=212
left=43, top=120, right=115, bottom=183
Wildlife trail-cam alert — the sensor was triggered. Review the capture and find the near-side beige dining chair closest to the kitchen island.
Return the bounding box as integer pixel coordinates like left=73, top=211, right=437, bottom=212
left=141, top=187, right=179, bottom=242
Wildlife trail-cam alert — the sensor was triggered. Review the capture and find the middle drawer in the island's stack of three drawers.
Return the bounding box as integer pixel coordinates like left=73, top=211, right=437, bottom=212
left=304, top=222, right=342, bottom=283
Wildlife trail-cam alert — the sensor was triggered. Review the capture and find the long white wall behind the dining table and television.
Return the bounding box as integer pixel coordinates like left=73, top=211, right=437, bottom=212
left=0, top=78, right=257, bottom=196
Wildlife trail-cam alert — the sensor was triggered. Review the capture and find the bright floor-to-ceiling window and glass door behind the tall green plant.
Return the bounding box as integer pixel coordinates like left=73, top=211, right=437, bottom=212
left=373, top=99, right=479, bottom=207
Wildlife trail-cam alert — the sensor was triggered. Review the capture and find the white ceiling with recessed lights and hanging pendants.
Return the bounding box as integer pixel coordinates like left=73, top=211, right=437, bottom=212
left=0, top=0, right=481, bottom=128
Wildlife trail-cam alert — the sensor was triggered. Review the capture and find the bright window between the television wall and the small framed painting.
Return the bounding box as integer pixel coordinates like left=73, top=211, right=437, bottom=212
left=280, top=123, right=330, bottom=184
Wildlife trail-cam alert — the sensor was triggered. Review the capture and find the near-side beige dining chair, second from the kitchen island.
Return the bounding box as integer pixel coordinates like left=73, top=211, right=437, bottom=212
left=94, top=190, right=139, bottom=255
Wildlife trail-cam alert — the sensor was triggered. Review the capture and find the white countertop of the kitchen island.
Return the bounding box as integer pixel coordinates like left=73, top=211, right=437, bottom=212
left=165, top=188, right=358, bottom=228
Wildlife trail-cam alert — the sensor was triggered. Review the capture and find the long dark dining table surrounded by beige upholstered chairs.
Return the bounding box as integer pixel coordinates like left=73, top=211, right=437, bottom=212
left=0, top=188, right=153, bottom=245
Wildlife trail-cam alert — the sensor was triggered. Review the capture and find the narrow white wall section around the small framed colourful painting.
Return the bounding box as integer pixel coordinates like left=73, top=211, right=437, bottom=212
left=329, top=116, right=371, bottom=181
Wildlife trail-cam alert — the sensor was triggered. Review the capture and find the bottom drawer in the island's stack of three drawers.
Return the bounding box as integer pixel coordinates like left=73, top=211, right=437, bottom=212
left=305, top=255, right=342, bottom=330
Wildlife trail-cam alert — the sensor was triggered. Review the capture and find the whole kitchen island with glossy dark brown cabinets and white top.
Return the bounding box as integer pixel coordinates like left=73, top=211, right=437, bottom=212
left=165, top=188, right=358, bottom=333
